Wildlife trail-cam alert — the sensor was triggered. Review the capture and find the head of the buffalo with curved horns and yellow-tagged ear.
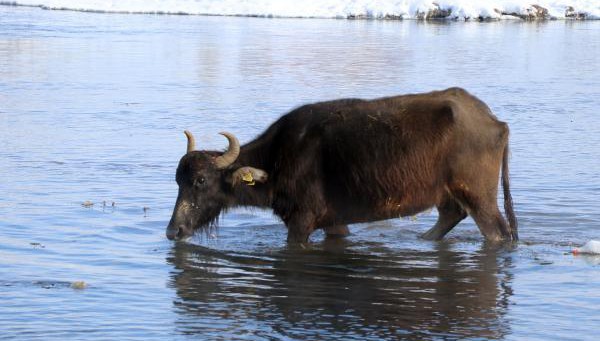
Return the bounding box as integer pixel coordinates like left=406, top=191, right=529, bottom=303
left=166, top=130, right=267, bottom=239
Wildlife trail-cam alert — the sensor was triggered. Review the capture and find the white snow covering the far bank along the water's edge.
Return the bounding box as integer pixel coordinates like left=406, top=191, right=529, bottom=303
left=0, top=0, right=600, bottom=20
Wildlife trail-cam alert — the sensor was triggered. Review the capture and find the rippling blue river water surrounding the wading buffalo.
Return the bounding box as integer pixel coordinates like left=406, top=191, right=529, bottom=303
left=0, top=6, right=600, bottom=340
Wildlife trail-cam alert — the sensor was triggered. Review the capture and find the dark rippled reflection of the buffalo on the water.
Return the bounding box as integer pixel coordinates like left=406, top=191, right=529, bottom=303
left=168, top=241, right=512, bottom=340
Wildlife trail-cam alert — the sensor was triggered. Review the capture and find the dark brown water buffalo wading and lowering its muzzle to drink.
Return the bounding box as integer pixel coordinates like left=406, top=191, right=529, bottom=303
left=166, top=88, right=518, bottom=243
